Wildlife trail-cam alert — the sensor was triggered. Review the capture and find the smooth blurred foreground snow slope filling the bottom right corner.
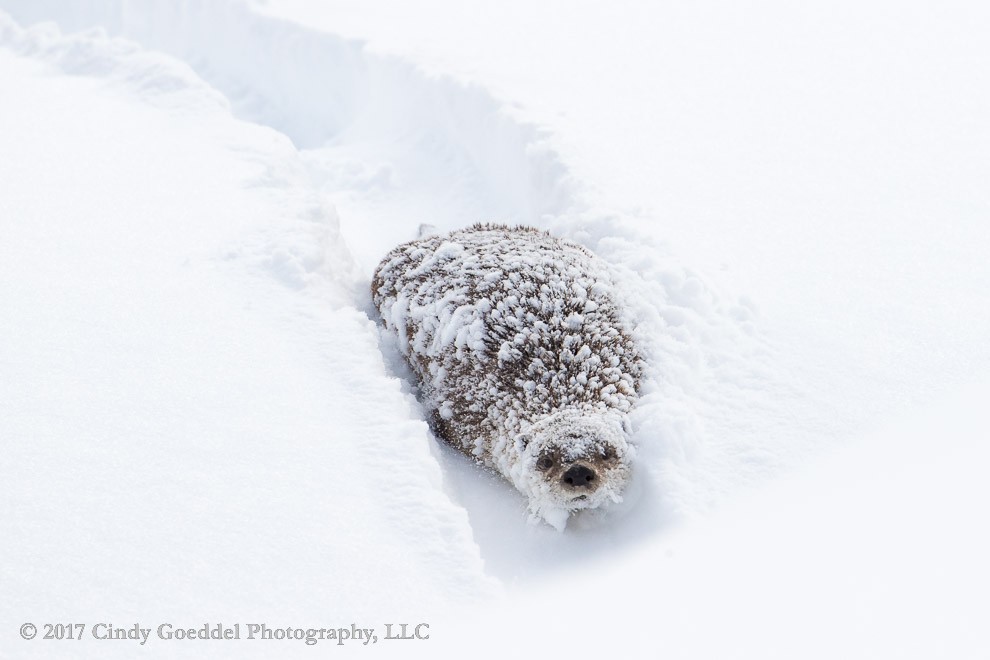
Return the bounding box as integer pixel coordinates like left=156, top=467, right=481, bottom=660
left=437, top=382, right=990, bottom=659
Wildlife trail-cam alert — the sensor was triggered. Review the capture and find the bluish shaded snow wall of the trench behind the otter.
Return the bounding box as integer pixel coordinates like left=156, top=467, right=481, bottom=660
left=4, top=0, right=569, bottom=224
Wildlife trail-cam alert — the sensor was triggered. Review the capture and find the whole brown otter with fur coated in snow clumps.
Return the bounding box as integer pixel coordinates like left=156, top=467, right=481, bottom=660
left=372, top=225, right=641, bottom=529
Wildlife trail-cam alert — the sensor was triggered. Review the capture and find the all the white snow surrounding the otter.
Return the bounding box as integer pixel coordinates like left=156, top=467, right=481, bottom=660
left=0, top=0, right=990, bottom=658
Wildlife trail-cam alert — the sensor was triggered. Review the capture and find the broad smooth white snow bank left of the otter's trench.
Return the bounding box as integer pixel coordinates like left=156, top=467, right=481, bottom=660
left=0, top=15, right=498, bottom=657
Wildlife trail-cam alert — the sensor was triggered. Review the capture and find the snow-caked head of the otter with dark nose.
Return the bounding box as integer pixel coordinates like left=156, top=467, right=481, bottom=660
left=513, top=410, right=633, bottom=528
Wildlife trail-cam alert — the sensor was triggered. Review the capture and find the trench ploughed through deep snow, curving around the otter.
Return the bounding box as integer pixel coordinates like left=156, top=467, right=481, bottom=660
left=3, top=0, right=800, bottom=576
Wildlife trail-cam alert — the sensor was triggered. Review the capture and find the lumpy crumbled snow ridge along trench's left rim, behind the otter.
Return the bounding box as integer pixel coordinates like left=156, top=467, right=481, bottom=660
left=0, top=7, right=357, bottom=306
